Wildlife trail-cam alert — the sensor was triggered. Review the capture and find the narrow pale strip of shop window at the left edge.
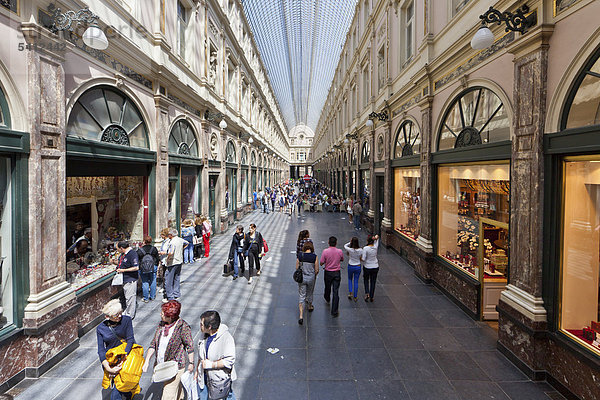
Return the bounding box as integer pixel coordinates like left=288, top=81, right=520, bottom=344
left=0, top=157, right=13, bottom=329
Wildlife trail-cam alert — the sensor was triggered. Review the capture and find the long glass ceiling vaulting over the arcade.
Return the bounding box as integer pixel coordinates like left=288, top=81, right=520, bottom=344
left=242, top=0, right=357, bottom=130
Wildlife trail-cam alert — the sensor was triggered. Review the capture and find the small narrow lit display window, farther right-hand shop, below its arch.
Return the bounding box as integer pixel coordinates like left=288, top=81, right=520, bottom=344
left=394, top=167, right=421, bottom=240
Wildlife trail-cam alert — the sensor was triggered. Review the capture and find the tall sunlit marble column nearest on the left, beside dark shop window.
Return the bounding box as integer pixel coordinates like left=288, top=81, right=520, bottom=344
left=22, top=22, right=77, bottom=326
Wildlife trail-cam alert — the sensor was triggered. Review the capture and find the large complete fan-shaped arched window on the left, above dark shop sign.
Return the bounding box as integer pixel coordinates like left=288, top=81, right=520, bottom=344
left=67, top=86, right=149, bottom=148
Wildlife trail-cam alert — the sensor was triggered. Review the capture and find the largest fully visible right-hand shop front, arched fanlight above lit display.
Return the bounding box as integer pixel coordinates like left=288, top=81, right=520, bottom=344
left=432, top=87, right=511, bottom=320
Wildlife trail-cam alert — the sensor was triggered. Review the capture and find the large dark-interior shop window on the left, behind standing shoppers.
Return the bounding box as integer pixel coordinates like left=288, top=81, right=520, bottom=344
left=66, top=176, right=145, bottom=290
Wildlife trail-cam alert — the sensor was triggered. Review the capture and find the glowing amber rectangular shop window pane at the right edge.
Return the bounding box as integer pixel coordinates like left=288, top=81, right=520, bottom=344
left=560, top=157, right=600, bottom=353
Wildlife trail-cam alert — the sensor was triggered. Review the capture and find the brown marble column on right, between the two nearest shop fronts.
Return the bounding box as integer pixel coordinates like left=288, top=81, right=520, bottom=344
left=499, top=25, right=553, bottom=328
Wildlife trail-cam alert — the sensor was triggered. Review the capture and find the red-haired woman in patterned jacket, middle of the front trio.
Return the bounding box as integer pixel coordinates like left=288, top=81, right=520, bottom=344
left=142, top=300, right=194, bottom=400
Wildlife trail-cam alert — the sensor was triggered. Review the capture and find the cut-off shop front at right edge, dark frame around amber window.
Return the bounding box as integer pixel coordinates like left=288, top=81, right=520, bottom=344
left=540, top=50, right=600, bottom=398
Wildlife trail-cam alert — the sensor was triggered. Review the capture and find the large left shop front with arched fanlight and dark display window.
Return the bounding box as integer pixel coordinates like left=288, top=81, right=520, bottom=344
left=65, top=86, right=156, bottom=325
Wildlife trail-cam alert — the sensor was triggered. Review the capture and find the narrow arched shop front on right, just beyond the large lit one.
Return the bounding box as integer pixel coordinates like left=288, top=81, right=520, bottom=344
left=388, top=119, right=422, bottom=264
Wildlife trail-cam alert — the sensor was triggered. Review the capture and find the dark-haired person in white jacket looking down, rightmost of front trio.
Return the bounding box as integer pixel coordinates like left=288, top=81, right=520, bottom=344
left=195, top=311, right=237, bottom=400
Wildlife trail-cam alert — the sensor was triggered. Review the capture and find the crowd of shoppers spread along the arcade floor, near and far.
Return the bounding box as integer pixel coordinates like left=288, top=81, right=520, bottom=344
left=96, top=182, right=379, bottom=400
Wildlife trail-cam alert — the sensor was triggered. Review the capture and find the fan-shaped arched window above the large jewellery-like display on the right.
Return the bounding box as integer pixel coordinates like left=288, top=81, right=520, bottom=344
left=437, top=87, right=510, bottom=150
